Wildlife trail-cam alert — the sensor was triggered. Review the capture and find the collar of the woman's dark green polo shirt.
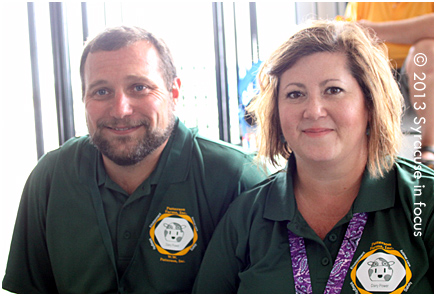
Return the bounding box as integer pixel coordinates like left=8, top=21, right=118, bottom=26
left=264, top=154, right=397, bottom=221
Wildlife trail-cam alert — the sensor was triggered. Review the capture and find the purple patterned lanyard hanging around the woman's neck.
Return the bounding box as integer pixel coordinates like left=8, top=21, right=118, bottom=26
left=288, top=213, right=368, bottom=294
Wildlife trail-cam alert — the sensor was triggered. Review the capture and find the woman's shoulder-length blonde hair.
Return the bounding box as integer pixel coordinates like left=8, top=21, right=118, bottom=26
left=248, top=21, right=404, bottom=178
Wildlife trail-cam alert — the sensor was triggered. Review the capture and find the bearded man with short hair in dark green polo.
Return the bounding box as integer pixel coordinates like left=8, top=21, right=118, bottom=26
left=3, top=27, right=264, bottom=293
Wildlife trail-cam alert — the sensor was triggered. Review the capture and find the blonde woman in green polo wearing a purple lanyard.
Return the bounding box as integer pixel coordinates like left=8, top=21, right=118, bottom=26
left=194, top=22, right=434, bottom=293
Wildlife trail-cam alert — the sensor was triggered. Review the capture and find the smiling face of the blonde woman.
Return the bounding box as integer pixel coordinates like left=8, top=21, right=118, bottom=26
left=278, top=52, right=368, bottom=164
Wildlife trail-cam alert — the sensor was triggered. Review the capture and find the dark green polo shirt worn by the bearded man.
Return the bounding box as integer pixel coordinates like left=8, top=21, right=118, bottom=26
left=3, top=122, right=265, bottom=293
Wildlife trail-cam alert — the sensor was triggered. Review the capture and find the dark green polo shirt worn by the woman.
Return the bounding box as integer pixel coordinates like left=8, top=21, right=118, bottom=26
left=194, top=157, right=434, bottom=294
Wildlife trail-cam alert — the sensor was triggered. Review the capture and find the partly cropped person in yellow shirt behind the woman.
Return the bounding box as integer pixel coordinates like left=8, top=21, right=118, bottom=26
left=345, top=2, right=434, bottom=168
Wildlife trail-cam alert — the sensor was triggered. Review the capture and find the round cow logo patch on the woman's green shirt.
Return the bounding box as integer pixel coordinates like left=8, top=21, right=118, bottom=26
left=350, top=242, right=412, bottom=294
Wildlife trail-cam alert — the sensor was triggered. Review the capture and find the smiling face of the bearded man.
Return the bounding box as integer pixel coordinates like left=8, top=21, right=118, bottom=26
left=84, top=41, right=180, bottom=166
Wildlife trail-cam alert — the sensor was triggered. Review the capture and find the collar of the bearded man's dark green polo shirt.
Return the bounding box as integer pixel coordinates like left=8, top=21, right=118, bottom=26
left=95, top=118, right=193, bottom=186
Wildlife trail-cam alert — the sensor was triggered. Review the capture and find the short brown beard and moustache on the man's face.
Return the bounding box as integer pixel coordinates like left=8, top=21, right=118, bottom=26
left=90, top=113, right=176, bottom=166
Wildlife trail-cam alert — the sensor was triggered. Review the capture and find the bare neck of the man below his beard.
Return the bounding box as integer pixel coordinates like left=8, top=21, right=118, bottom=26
left=103, top=140, right=168, bottom=195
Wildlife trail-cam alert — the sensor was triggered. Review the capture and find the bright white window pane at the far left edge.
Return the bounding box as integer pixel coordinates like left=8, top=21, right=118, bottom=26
left=0, top=1, right=37, bottom=280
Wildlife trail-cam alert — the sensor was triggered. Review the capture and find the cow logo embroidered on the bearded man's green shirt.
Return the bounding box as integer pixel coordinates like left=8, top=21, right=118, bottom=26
left=150, top=207, right=198, bottom=263
